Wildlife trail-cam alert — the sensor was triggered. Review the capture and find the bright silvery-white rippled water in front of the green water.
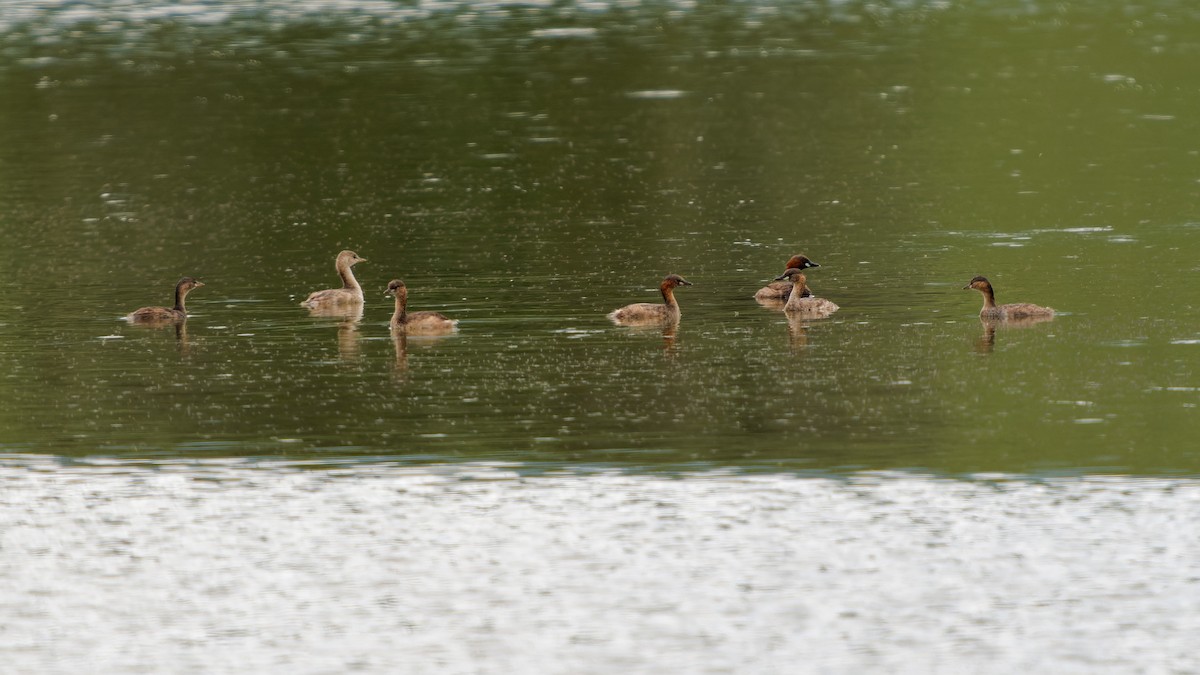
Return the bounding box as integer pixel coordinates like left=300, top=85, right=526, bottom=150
left=7, top=458, right=1200, bottom=673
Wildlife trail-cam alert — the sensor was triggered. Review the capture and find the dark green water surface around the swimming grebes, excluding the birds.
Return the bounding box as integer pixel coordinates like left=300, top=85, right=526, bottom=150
left=0, top=2, right=1200, bottom=474
